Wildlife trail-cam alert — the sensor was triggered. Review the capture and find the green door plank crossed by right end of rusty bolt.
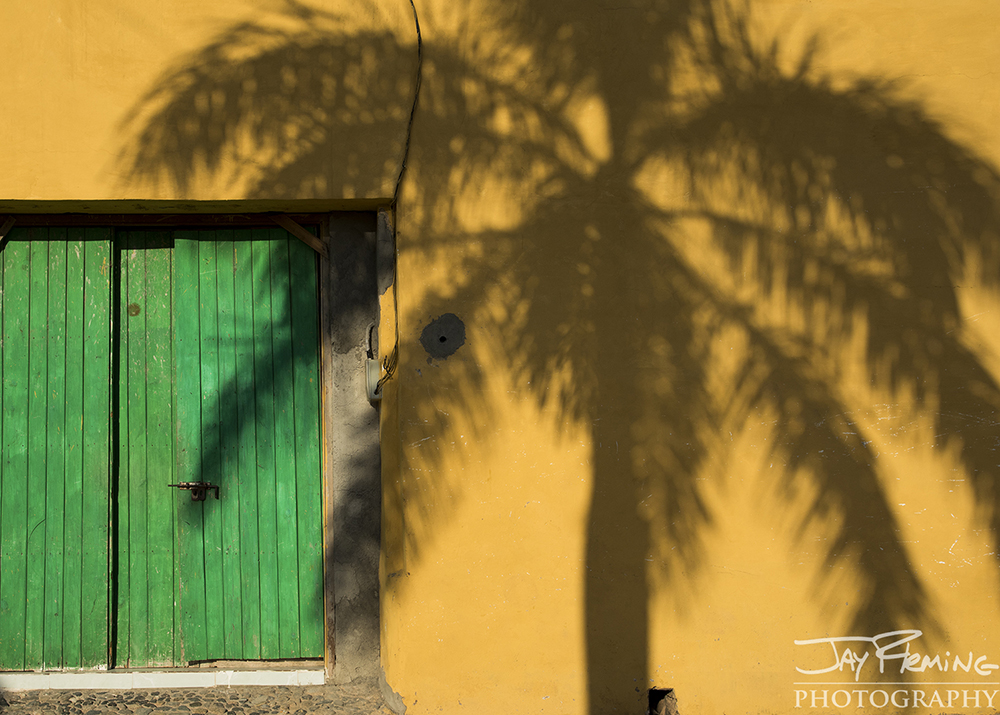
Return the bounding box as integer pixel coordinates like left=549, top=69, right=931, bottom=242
left=198, top=231, right=228, bottom=658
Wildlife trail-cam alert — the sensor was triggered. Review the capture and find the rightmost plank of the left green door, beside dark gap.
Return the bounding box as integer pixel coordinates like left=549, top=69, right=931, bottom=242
left=81, top=228, right=111, bottom=667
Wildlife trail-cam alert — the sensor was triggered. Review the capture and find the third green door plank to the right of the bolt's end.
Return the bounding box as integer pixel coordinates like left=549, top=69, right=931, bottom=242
left=252, top=229, right=281, bottom=658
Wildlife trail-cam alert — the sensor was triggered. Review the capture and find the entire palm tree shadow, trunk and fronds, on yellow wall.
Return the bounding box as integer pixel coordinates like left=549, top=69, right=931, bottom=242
left=121, top=0, right=1000, bottom=712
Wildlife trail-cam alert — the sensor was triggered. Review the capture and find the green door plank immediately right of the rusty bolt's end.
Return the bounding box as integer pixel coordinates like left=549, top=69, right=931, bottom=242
left=215, top=229, right=244, bottom=659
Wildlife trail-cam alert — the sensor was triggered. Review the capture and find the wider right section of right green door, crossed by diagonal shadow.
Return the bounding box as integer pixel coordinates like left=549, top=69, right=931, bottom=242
left=174, top=229, right=323, bottom=661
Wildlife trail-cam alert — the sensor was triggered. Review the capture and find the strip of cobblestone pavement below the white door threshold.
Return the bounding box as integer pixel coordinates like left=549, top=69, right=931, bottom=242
left=0, top=683, right=392, bottom=715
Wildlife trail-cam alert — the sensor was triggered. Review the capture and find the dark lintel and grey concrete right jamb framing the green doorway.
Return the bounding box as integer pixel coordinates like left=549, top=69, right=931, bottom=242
left=0, top=206, right=384, bottom=683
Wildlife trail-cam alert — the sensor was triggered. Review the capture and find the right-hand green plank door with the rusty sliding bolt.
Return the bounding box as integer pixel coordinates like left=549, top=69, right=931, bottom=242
left=116, top=229, right=323, bottom=667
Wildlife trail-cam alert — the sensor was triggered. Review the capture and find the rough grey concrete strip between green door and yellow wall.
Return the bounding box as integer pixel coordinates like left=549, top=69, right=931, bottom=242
left=326, top=217, right=382, bottom=684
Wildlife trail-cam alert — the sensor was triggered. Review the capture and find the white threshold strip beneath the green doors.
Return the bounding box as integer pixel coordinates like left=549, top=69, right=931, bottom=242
left=0, top=669, right=326, bottom=691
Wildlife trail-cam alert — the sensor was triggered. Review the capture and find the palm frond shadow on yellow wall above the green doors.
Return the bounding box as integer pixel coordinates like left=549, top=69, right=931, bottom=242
left=117, top=3, right=414, bottom=199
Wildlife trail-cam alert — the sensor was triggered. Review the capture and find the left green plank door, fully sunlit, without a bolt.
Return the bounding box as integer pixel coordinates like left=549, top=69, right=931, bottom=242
left=0, top=228, right=111, bottom=670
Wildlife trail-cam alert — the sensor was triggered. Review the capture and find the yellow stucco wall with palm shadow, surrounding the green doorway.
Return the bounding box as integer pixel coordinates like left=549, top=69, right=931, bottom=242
left=0, top=0, right=1000, bottom=715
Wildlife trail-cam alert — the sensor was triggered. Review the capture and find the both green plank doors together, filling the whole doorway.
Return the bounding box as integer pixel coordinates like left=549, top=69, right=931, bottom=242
left=0, top=229, right=323, bottom=670
